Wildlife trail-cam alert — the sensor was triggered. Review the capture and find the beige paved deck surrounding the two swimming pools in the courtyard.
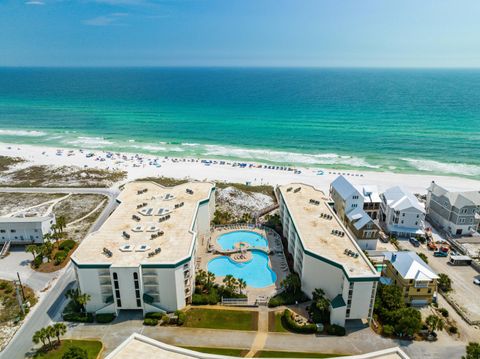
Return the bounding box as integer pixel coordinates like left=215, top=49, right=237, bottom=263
left=197, top=225, right=289, bottom=302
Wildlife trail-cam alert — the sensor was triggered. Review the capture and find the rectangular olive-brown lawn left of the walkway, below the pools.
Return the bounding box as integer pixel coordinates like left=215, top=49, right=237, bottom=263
left=183, top=308, right=258, bottom=330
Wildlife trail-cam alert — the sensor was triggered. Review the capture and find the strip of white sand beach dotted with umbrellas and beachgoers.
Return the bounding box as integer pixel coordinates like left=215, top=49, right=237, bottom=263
left=0, top=143, right=480, bottom=194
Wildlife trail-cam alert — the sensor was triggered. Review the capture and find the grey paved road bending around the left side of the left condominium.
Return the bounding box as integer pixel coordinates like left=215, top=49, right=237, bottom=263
left=0, top=188, right=119, bottom=359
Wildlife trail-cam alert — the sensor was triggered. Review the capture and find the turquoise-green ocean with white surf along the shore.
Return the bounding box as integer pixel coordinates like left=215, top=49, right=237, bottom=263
left=0, top=68, right=480, bottom=178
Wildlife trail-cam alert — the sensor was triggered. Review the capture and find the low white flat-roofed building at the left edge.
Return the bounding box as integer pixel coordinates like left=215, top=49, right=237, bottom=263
left=0, top=213, right=55, bottom=244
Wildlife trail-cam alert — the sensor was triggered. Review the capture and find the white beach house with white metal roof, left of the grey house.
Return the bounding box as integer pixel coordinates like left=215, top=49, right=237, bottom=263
left=380, top=186, right=425, bottom=237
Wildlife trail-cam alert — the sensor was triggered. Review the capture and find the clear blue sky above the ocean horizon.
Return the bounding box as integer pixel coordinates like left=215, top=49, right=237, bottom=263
left=0, top=0, right=480, bottom=67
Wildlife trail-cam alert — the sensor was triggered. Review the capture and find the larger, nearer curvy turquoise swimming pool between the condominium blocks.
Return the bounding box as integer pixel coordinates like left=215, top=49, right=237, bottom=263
left=207, top=250, right=277, bottom=288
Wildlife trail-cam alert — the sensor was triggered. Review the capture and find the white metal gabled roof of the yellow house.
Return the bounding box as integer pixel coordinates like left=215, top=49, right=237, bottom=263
left=384, top=251, right=438, bottom=281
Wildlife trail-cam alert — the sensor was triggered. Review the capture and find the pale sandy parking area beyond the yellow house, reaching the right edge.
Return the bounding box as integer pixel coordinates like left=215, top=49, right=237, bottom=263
left=399, top=240, right=480, bottom=321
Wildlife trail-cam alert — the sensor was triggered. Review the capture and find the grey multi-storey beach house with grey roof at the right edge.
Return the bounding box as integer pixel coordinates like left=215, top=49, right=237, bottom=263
left=426, top=182, right=480, bottom=236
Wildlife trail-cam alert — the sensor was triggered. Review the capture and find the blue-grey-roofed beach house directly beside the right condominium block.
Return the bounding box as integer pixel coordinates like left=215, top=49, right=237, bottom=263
left=330, top=176, right=380, bottom=250
